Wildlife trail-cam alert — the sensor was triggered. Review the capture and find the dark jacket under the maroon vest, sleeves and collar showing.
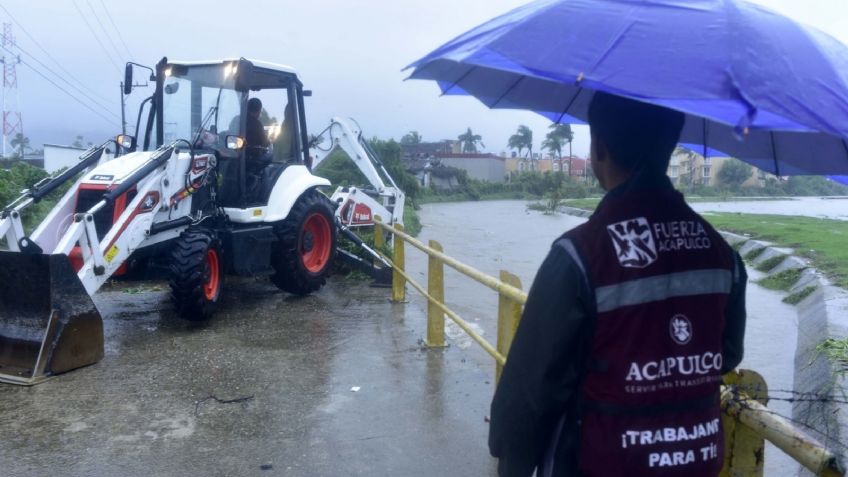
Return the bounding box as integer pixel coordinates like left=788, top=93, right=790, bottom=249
left=489, top=176, right=747, bottom=476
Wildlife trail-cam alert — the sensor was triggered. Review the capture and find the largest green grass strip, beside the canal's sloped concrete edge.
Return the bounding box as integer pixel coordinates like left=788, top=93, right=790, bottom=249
left=704, top=213, right=848, bottom=288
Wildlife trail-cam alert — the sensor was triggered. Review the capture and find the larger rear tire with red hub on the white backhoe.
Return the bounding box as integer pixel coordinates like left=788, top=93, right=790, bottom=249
left=271, top=189, right=336, bottom=295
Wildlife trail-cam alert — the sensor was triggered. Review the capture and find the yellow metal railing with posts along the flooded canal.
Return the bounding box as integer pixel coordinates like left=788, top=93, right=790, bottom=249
left=374, top=217, right=845, bottom=477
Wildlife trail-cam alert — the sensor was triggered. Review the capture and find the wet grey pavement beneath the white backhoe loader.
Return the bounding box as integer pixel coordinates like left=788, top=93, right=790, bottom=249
left=0, top=277, right=495, bottom=476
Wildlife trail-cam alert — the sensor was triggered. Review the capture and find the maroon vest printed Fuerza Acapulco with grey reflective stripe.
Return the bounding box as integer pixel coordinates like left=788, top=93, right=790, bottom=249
left=563, top=189, right=735, bottom=477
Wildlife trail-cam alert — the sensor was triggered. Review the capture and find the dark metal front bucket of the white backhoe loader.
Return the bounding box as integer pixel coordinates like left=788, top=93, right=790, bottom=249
left=0, top=251, right=103, bottom=386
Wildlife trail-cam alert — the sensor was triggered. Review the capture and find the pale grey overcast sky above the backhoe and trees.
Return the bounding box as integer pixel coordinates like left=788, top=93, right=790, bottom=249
left=0, top=0, right=848, bottom=156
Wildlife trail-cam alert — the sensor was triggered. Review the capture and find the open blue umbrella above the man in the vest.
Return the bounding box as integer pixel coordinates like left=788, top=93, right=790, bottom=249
left=407, top=0, right=848, bottom=175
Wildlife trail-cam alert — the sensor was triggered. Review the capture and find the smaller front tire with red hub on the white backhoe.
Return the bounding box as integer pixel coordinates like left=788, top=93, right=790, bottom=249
left=169, top=227, right=224, bottom=321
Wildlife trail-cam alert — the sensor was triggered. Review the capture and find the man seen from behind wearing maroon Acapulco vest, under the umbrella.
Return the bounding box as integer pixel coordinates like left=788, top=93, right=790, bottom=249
left=489, top=92, right=747, bottom=477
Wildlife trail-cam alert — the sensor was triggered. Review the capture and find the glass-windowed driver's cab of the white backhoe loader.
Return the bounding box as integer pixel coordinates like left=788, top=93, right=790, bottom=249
left=127, top=58, right=308, bottom=209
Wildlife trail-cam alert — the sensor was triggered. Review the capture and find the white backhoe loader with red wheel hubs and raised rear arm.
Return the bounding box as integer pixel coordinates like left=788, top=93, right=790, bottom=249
left=0, top=58, right=403, bottom=385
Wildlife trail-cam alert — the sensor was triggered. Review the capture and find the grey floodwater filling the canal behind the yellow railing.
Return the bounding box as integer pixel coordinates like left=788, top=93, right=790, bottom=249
left=406, top=201, right=800, bottom=476
